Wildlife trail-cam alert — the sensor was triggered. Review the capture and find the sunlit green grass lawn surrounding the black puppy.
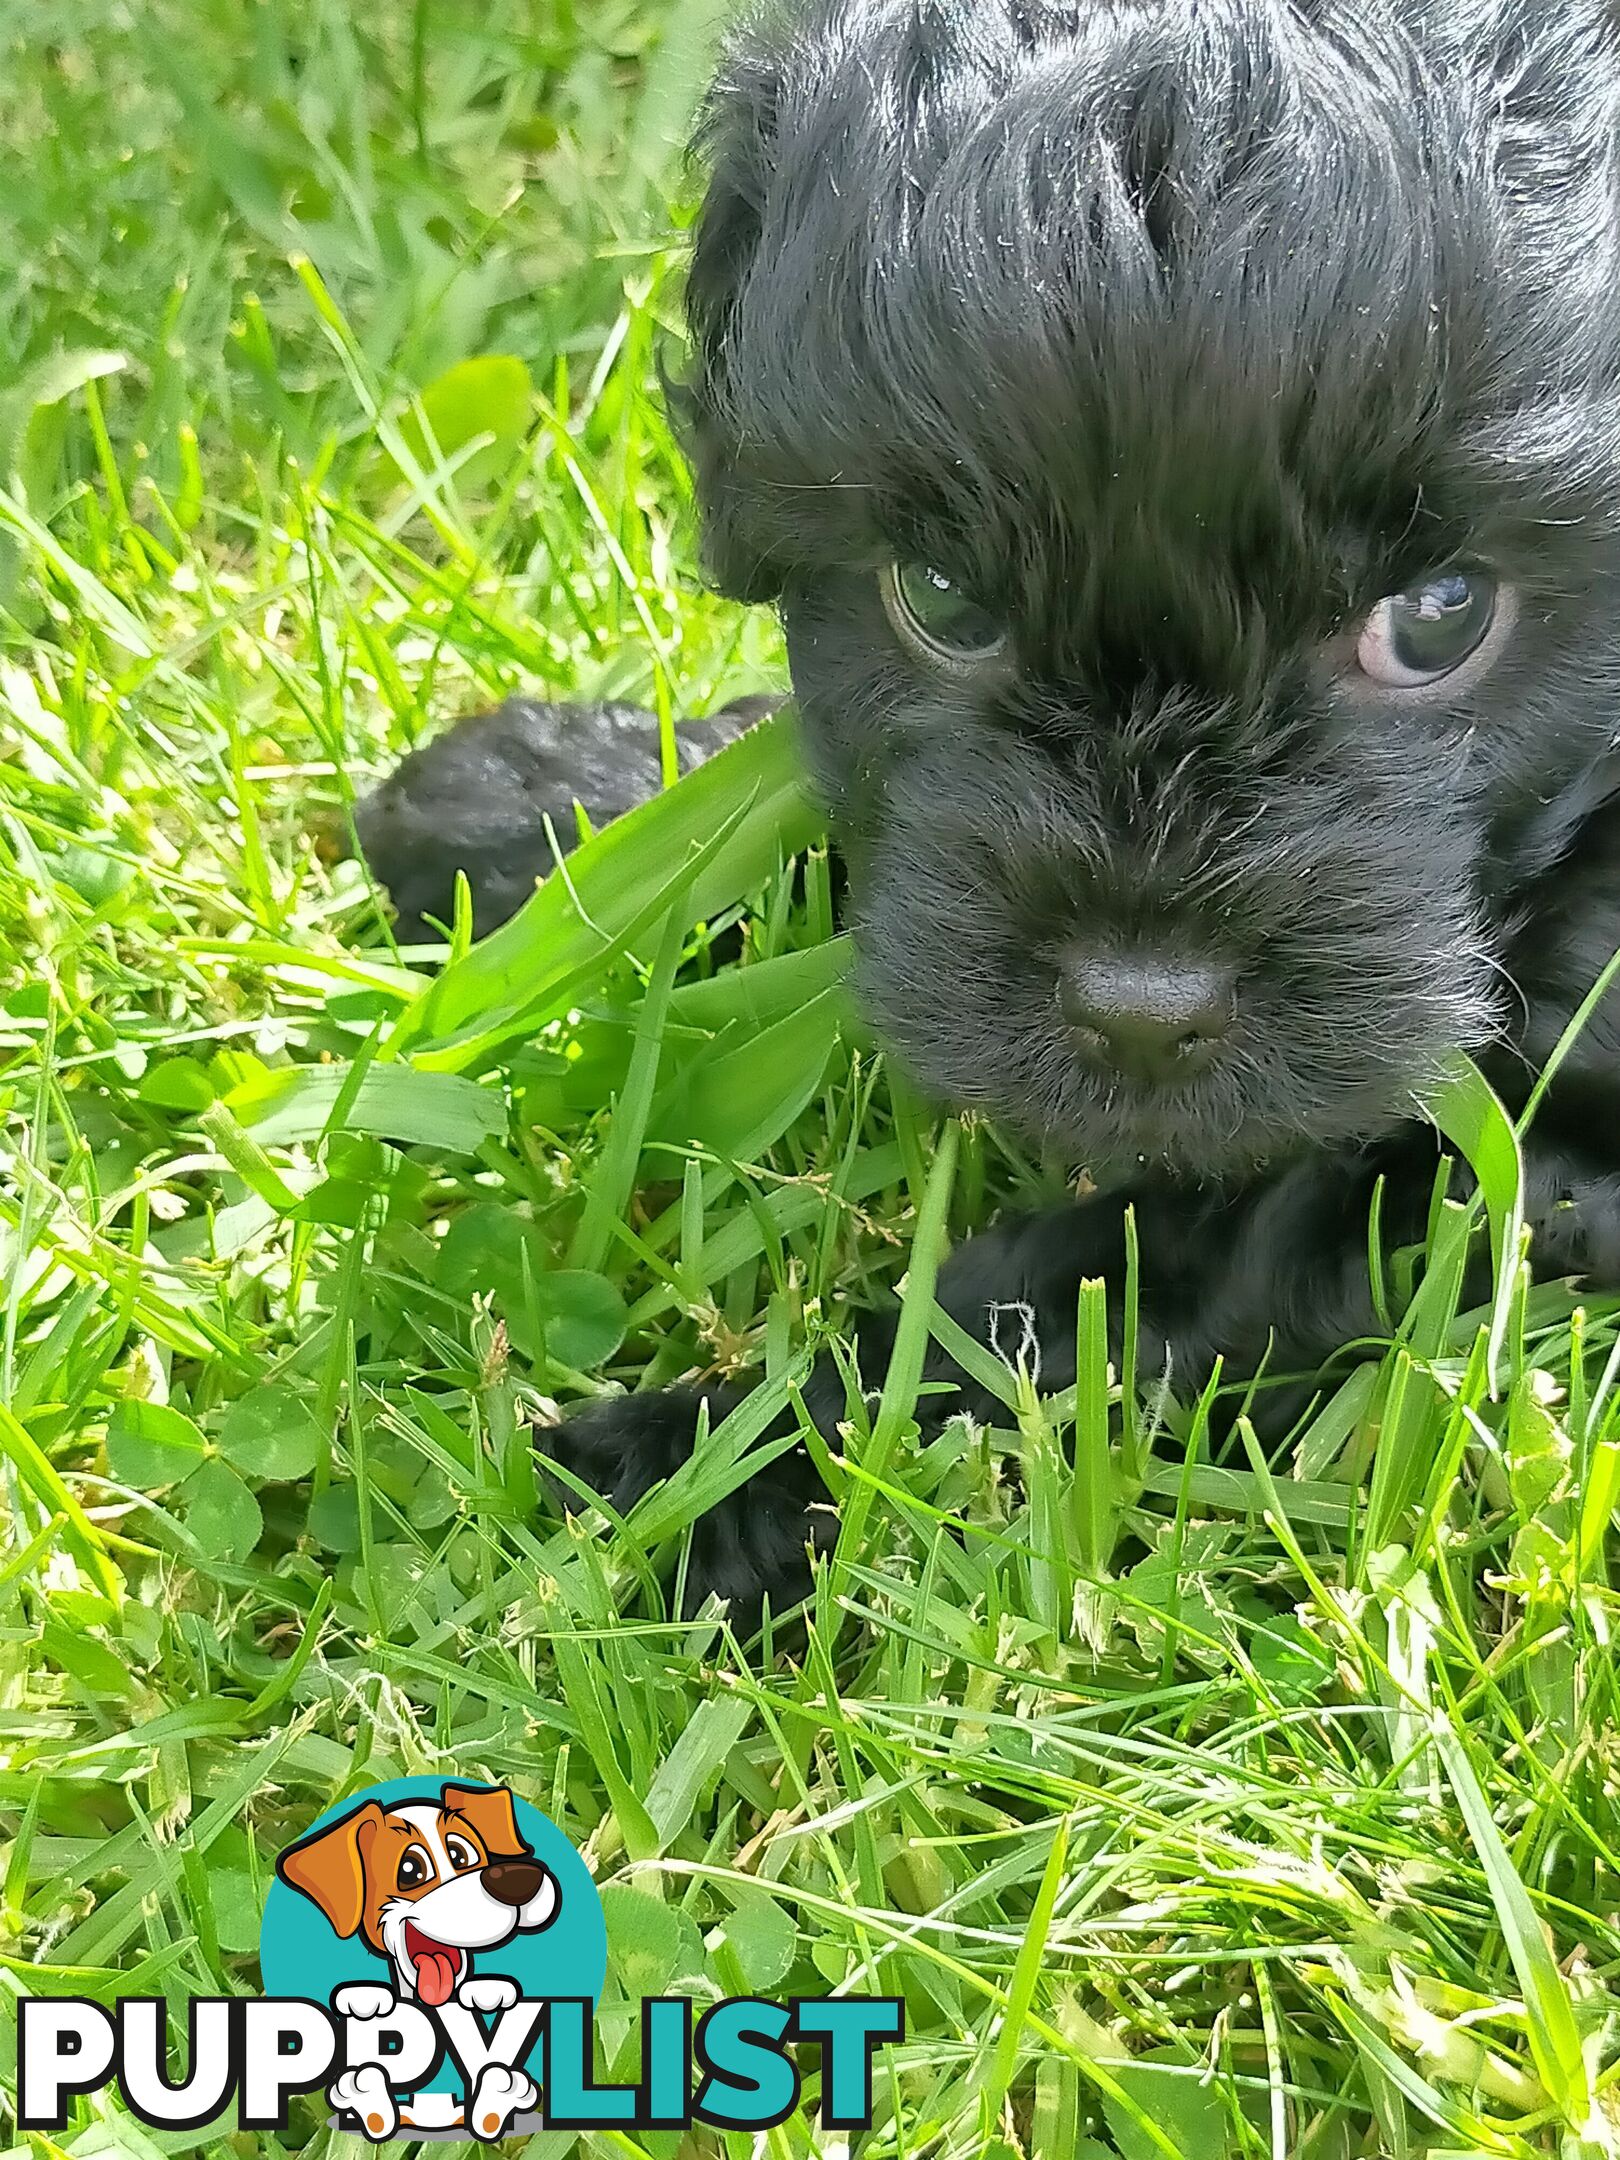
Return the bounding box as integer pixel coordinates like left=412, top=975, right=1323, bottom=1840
left=0, top=0, right=1620, bottom=2160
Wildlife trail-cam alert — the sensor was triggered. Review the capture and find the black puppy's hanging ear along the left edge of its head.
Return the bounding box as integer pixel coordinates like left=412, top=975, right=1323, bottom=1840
left=665, top=43, right=782, bottom=600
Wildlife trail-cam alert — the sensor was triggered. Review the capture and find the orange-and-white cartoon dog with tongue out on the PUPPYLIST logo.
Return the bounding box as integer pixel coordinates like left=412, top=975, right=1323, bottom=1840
left=276, top=1784, right=562, bottom=2138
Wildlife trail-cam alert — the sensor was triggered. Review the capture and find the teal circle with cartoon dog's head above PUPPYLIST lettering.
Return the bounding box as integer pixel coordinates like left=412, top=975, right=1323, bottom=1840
left=259, top=1778, right=607, bottom=2128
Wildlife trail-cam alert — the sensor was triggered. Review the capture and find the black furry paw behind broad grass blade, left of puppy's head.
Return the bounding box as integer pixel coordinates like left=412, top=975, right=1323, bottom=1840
left=354, top=698, right=778, bottom=944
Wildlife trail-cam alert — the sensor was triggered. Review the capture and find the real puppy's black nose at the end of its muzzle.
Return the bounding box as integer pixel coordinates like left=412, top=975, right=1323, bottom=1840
left=1058, top=946, right=1238, bottom=1082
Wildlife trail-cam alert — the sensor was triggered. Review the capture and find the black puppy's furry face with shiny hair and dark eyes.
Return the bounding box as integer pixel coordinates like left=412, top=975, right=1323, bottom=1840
left=689, top=0, right=1620, bottom=1173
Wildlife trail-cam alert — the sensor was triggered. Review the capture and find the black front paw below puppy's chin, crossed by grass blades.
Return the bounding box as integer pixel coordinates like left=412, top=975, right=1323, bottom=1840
left=540, top=1387, right=836, bottom=1622
